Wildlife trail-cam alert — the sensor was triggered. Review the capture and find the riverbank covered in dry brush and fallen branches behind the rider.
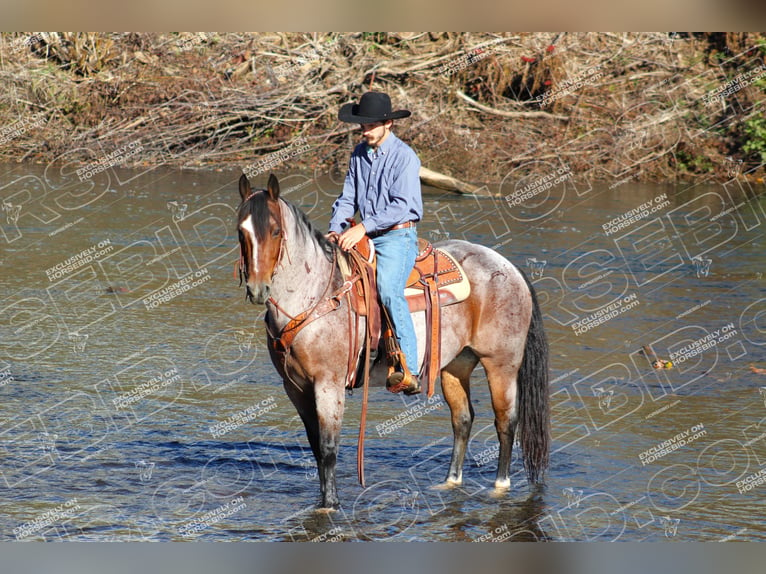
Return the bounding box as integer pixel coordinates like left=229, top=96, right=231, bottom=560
left=0, top=33, right=766, bottom=184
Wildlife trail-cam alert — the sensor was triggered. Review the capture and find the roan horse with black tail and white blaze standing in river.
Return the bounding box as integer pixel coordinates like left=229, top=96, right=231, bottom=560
left=237, top=174, right=550, bottom=509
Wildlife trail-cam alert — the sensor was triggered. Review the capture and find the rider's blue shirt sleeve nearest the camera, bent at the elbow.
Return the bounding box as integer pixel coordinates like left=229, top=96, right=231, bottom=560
left=362, top=152, right=422, bottom=237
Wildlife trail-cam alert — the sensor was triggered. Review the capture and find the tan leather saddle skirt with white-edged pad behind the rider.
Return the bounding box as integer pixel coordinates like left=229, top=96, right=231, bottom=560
left=404, top=247, right=471, bottom=313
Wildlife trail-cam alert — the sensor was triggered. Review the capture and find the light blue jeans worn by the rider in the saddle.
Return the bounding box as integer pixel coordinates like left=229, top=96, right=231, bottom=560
left=372, top=227, right=418, bottom=375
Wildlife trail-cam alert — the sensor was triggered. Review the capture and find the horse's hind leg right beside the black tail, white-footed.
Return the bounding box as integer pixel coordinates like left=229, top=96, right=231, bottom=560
left=481, top=357, right=518, bottom=488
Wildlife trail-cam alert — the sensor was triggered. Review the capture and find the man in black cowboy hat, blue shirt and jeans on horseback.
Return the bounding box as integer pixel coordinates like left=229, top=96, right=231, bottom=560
left=329, top=92, right=423, bottom=395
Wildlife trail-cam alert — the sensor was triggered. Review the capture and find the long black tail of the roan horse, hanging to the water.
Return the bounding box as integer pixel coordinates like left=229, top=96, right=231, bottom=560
left=517, top=270, right=550, bottom=482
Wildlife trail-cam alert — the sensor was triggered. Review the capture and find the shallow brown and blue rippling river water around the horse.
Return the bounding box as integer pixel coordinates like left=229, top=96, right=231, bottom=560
left=0, top=166, right=766, bottom=541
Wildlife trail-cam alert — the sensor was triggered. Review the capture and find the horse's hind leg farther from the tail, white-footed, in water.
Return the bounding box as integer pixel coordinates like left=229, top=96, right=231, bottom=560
left=441, top=349, right=478, bottom=485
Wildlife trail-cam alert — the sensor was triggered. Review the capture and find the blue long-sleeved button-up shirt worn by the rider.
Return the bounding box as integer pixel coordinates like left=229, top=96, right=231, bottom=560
left=330, top=132, right=423, bottom=233
